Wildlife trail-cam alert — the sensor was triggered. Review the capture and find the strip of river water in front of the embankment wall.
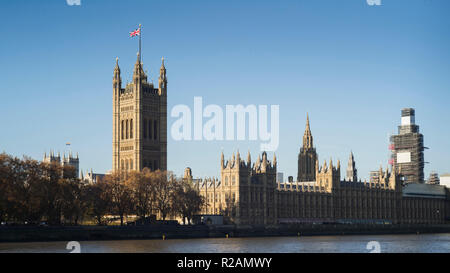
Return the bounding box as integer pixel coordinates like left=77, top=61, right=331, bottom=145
left=0, top=233, right=450, bottom=253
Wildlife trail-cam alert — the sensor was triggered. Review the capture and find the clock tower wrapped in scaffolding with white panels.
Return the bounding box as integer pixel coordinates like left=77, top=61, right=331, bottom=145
left=390, top=108, right=425, bottom=183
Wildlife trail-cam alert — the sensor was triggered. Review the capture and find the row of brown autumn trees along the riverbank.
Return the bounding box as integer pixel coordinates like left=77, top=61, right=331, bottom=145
left=0, top=153, right=205, bottom=225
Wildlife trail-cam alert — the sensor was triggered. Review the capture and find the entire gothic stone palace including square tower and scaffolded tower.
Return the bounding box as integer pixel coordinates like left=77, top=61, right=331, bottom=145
left=112, top=52, right=450, bottom=225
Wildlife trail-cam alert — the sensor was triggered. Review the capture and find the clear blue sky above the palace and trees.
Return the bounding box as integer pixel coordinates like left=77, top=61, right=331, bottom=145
left=0, top=0, right=450, bottom=181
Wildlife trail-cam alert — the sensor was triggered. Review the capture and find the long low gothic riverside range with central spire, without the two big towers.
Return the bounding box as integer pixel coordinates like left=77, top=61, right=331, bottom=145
left=185, top=116, right=450, bottom=225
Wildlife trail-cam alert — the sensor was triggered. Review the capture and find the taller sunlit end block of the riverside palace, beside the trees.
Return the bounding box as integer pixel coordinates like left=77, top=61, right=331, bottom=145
left=185, top=152, right=277, bottom=225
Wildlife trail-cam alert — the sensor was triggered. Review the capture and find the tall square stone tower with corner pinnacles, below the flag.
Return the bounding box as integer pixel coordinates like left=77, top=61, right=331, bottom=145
left=113, top=54, right=167, bottom=171
